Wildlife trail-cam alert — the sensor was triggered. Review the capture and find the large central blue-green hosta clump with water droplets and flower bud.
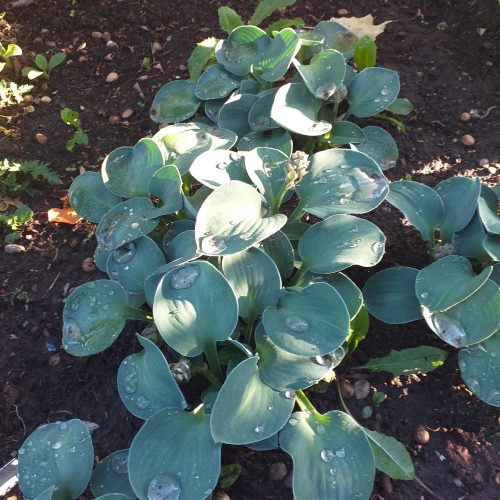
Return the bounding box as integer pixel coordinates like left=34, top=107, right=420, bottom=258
left=19, top=7, right=413, bottom=500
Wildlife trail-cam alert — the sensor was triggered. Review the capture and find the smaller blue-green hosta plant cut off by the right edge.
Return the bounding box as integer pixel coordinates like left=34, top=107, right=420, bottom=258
left=363, top=177, right=500, bottom=406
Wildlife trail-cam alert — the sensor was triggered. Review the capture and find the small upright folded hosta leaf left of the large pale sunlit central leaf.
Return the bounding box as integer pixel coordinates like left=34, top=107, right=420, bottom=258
left=149, top=165, right=182, bottom=217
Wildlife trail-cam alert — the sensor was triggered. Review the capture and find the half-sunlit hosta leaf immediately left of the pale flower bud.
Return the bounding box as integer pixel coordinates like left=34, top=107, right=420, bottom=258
left=245, top=148, right=289, bottom=208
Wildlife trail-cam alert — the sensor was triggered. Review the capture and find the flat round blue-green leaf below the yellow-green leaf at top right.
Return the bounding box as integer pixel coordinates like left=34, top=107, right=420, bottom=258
left=347, top=68, right=399, bottom=118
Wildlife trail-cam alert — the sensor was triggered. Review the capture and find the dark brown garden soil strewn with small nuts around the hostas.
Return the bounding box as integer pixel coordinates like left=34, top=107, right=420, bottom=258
left=0, top=0, right=500, bottom=500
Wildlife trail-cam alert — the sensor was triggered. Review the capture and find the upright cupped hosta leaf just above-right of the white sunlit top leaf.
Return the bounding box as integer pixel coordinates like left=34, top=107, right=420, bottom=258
left=294, top=49, right=346, bottom=99
